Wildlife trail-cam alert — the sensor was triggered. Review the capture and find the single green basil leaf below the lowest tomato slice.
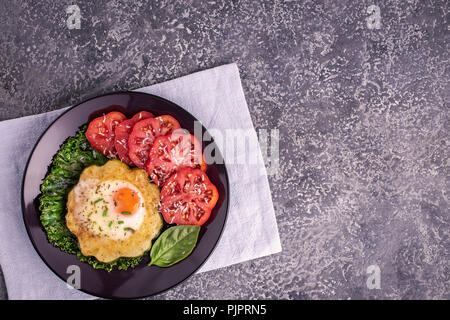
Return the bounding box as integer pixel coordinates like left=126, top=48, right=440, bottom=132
left=149, top=226, right=200, bottom=267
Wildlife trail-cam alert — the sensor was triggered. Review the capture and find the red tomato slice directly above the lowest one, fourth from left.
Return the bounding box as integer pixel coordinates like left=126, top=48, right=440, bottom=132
left=145, top=133, right=206, bottom=187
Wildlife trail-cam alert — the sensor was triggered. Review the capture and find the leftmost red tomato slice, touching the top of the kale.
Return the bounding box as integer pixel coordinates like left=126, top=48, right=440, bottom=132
left=86, top=111, right=127, bottom=158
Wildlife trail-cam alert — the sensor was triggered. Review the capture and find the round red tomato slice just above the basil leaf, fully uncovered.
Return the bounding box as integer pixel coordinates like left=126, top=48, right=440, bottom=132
left=160, top=168, right=219, bottom=226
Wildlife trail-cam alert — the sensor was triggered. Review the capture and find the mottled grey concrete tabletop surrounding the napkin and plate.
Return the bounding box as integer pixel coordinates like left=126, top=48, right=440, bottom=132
left=0, top=0, right=450, bottom=299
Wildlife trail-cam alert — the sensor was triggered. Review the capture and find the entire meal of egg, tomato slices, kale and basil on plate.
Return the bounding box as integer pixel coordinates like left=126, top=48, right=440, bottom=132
left=39, top=111, right=219, bottom=271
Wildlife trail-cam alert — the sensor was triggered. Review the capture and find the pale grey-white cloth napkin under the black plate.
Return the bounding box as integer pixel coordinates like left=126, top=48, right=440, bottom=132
left=0, top=64, right=281, bottom=299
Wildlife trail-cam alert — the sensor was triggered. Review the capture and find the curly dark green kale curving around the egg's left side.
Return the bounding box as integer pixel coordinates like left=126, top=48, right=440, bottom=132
left=39, top=125, right=142, bottom=271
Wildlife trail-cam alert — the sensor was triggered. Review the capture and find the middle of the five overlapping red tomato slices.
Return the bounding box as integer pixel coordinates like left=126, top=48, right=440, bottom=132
left=128, top=115, right=181, bottom=169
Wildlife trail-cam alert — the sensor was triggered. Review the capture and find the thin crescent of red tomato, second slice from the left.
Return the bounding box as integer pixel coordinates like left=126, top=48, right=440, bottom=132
left=114, top=111, right=154, bottom=166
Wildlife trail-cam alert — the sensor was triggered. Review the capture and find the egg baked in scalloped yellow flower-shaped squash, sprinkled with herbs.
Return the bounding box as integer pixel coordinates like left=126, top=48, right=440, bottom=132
left=66, top=160, right=162, bottom=262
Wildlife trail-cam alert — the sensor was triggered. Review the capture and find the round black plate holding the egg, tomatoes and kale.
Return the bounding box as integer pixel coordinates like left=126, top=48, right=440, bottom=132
left=22, top=92, right=229, bottom=298
